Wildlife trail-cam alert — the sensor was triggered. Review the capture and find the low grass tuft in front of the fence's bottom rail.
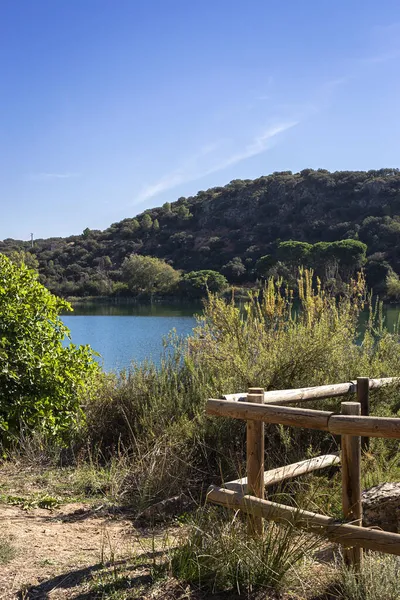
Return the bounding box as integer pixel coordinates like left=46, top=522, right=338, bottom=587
left=171, top=508, right=317, bottom=594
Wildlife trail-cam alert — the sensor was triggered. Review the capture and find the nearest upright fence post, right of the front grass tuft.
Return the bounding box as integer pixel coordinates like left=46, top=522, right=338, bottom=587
left=341, top=402, right=363, bottom=571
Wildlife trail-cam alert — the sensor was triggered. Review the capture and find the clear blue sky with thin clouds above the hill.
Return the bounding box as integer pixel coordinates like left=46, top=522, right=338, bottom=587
left=0, top=0, right=400, bottom=239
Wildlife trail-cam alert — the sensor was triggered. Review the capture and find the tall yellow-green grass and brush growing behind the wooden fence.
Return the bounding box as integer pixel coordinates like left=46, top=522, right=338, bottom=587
left=73, top=271, right=400, bottom=508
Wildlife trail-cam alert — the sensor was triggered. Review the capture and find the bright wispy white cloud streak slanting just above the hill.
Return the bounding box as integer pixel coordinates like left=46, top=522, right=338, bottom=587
left=136, top=120, right=299, bottom=202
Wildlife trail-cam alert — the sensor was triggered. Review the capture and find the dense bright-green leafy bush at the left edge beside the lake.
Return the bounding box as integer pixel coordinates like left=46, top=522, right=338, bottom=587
left=0, top=254, right=98, bottom=445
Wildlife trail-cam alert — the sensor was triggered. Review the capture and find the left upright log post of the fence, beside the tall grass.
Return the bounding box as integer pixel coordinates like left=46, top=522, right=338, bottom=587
left=246, top=388, right=264, bottom=535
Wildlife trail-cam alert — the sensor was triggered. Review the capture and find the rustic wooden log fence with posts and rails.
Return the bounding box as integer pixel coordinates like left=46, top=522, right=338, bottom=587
left=206, top=377, right=400, bottom=569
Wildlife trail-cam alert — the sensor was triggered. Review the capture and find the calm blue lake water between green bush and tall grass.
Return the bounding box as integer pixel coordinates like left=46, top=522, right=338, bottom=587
left=63, top=304, right=201, bottom=371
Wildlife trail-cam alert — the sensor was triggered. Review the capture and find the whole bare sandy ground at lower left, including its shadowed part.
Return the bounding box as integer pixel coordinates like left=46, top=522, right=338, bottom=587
left=0, top=463, right=335, bottom=600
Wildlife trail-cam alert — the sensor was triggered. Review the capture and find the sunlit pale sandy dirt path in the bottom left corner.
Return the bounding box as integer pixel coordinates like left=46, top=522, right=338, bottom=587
left=0, top=504, right=147, bottom=600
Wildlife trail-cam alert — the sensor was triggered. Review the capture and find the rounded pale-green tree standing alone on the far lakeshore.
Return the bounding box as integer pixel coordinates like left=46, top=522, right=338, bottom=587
left=122, top=254, right=179, bottom=294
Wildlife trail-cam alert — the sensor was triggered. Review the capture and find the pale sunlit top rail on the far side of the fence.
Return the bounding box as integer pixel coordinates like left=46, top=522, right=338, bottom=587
left=223, top=377, right=400, bottom=404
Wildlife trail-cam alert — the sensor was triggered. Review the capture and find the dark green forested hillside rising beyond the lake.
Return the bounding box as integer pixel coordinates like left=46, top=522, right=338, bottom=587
left=0, top=169, right=400, bottom=296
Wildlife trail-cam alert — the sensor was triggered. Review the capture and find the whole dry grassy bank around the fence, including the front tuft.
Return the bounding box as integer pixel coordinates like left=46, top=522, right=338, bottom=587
left=3, top=272, right=400, bottom=600
